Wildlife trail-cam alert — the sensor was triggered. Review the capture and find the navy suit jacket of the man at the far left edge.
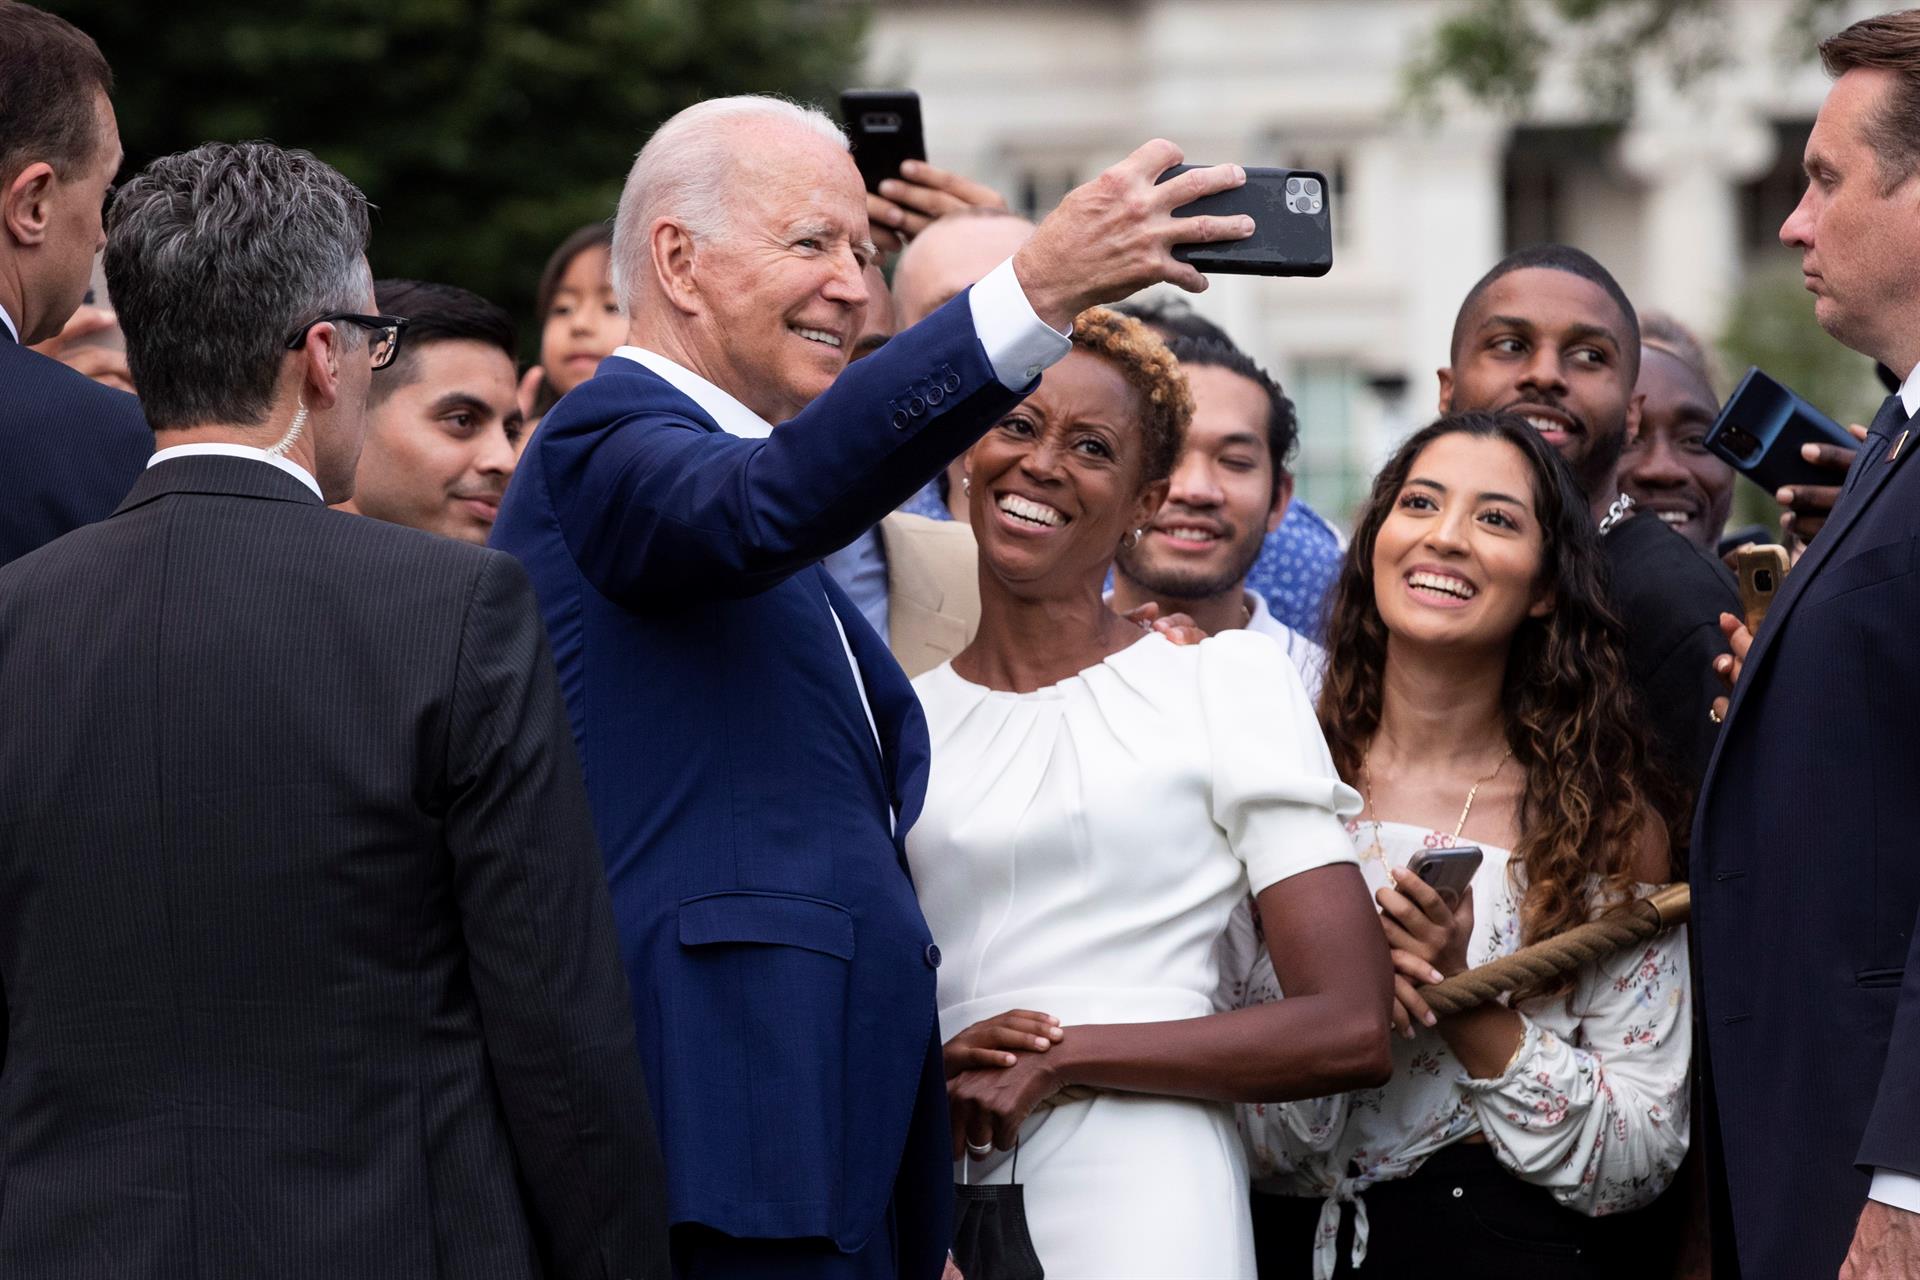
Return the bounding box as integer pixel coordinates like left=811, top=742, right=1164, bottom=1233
left=0, top=324, right=154, bottom=564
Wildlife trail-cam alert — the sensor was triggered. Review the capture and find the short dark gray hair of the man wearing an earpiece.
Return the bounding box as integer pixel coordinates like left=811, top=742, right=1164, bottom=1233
left=106, top=142, right=372, bottom=430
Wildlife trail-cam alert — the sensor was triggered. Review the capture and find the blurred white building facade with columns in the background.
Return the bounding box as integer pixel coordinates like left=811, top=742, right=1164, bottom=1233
left=866, top=0, right=1858, bottom=524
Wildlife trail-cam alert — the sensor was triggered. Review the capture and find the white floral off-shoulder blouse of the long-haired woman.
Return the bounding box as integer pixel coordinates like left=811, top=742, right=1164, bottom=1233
left=1221, top=821, right=1692, bottom=1280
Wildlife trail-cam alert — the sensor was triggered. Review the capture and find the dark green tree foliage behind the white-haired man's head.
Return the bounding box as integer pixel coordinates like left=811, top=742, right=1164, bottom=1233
left=54, top=0, right=866, bottom=345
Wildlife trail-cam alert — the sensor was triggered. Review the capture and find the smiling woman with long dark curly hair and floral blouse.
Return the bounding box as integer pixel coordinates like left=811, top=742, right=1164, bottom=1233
left=1242, top=413, right=1690, bottom=1280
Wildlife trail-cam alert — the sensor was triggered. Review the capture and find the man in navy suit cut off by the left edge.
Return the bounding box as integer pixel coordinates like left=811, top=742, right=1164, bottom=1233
left=0, top=4, right=154, bottom=568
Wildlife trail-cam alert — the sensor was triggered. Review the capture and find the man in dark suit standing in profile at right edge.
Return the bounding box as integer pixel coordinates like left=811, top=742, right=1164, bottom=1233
left=1693, top=10, right=1920, bottom=1280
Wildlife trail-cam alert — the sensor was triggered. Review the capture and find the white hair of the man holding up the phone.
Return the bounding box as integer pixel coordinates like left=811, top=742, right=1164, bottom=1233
left=611, top=94, right=847, bottom=309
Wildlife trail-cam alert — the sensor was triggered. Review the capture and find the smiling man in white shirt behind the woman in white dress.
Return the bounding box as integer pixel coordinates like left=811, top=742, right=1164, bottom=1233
left=1112, top=338, right=1327, bottom=699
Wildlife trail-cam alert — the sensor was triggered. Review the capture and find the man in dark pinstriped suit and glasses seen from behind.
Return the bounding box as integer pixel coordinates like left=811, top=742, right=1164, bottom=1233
left=0, top=144, right=666, bottom=1280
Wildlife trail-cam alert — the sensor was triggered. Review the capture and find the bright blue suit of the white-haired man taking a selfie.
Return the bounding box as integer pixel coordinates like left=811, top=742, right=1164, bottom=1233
left=493, top=296, right=1020, bottom=1276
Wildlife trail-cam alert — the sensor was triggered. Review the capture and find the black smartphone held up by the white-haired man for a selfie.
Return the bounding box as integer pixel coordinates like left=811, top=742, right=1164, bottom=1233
left=1158, top=165, right=1332, bottom=276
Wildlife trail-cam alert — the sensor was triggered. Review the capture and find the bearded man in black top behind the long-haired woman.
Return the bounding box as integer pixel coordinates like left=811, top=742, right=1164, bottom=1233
left=1440, top=244, right=1740, bottom=789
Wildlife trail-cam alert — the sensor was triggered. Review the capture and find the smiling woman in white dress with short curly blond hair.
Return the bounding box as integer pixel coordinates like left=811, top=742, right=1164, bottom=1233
left=906, top=309, right=1390, bottom=1280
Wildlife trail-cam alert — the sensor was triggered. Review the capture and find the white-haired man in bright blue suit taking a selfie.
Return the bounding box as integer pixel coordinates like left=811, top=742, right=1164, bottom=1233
left=493, top=98, right=1252, bottom=1280
